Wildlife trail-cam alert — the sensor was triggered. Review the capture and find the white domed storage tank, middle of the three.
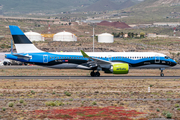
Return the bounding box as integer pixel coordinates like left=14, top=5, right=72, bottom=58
left=53, top=31, right=77, bottom=41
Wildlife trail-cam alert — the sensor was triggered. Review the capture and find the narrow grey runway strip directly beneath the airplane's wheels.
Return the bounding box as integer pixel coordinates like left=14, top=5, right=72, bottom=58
left=0, top=76, right=180, bottom=79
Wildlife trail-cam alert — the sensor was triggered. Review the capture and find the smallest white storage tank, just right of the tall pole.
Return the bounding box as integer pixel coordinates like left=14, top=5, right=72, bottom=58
left=98, top=33, right=114, bottom=43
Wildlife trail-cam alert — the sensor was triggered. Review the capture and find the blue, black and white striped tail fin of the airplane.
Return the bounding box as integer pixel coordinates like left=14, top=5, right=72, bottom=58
left=9, top=25, right=42, bottom=53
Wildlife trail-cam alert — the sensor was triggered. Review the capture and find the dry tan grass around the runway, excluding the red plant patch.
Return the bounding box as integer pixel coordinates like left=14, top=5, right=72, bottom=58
left=0, top=69, right=180, bottom=119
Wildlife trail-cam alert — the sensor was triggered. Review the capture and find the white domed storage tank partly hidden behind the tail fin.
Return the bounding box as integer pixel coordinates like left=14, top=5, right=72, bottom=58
left=24, top=32, right=44, bottom=42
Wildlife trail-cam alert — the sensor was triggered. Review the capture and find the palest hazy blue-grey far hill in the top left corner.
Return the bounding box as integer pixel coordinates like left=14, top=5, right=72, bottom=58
left=0, top=0, right=98, bottom=14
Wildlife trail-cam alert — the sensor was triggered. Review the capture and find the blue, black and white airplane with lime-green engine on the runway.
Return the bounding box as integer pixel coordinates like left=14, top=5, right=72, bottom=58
left=5, top=25, right=177, bottom=77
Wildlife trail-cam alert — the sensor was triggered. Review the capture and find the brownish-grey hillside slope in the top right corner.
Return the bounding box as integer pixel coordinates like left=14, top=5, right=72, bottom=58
left=123, top=0, right=180, bottom=24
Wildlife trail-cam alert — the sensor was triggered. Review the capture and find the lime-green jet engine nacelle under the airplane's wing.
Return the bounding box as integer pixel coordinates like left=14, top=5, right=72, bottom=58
left=110, top=63, right=129, bottom=74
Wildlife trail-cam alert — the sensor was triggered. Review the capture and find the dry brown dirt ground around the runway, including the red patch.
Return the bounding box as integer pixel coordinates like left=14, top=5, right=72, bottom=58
left=0, top=69, right=180, bottom=120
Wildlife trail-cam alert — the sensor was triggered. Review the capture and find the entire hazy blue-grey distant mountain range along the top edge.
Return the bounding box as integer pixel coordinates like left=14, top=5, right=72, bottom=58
left=0, top=0, right=138, bottom=15
